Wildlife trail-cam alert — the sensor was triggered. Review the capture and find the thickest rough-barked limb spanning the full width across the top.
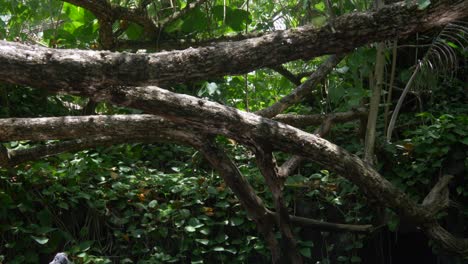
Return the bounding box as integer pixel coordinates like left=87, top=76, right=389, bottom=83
left=0, top=0, right=468, bottom=89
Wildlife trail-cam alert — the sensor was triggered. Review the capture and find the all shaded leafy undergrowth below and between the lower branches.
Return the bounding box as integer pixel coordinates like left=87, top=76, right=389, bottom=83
left=0, top=113, right=468, bottom=263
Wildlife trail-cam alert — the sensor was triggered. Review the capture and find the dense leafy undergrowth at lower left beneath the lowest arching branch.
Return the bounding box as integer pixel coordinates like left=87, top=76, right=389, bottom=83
left=0, top=145, right=268, bottom=263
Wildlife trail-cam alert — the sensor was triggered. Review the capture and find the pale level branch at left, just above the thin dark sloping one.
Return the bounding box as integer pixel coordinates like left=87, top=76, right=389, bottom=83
left=0, top=115, right=182, bottom=141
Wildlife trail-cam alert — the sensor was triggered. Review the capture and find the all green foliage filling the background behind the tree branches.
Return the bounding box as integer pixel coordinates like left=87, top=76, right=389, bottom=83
left=0, top=0, right=468, bottom=263
